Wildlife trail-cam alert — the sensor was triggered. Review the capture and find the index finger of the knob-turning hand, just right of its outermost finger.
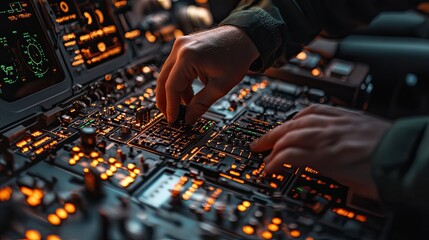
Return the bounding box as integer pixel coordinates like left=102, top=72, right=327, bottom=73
left=165, top=60, right=197, bottom=123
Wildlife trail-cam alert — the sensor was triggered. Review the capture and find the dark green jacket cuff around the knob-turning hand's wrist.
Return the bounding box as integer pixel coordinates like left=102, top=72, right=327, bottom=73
left=220, top=8, right=285, bottom=72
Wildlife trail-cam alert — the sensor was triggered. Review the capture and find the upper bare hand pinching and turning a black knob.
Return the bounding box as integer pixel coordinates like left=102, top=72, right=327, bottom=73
left=156, top=26, right=259, bottom=124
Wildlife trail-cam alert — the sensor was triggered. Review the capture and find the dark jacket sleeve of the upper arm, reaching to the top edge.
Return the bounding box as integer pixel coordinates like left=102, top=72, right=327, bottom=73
left=220, top=0, right=419, bottom=71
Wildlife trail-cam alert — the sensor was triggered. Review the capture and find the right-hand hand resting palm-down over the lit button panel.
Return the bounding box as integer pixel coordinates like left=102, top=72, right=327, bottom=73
left=251, top=105, right=391, bottom=199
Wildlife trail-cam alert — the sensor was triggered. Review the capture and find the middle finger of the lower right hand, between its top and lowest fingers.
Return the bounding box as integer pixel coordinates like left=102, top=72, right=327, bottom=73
left=271, top=128, right=325, bottom=159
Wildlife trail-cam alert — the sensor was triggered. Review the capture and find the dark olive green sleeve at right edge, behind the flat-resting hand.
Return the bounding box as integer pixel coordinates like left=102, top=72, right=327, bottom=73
left=373, top=117, right=429, bottom=212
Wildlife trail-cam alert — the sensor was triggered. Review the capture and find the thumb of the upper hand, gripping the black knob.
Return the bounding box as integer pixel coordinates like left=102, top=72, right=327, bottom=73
left=185, top=81, right=223, bottom=124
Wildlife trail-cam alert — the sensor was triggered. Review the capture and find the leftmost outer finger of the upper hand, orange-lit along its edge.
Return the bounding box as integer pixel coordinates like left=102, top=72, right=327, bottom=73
left=155, top=55, right=175, bottom=115
